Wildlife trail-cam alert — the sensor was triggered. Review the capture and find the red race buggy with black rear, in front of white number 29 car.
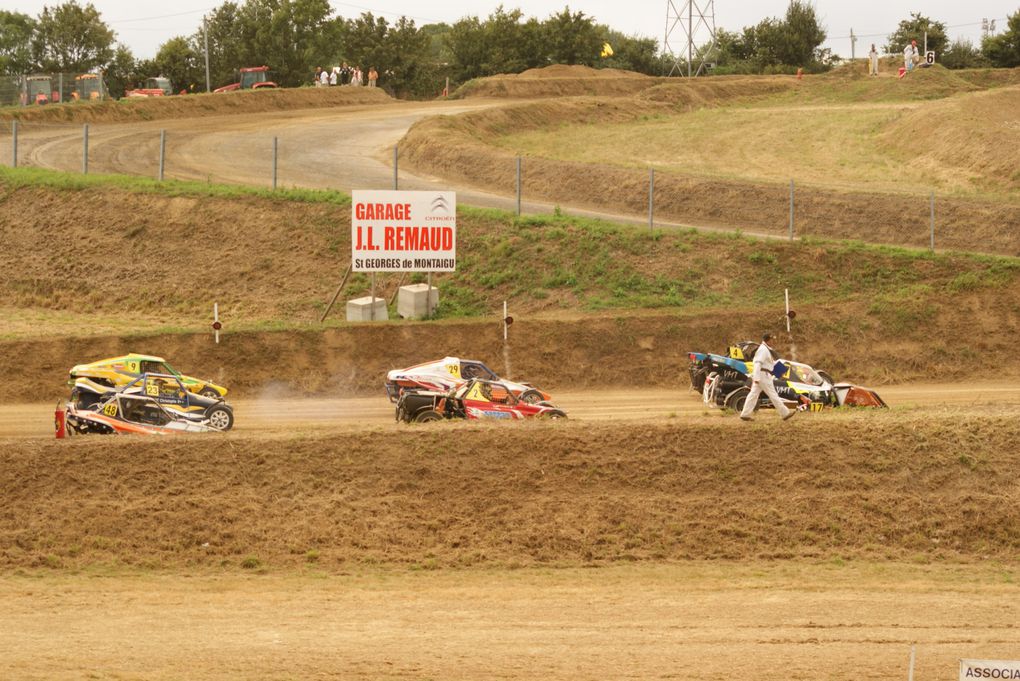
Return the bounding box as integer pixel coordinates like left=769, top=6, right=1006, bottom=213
left=397, top=378, right=566, bottom=423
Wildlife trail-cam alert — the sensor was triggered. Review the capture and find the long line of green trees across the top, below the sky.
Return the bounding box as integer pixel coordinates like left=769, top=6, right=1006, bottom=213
left=0, top=0, right=1020, bottom=97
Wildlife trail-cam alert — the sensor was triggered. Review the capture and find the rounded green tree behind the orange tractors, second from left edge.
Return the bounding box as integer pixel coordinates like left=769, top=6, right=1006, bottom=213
left=32, top=0, right=115, bottom=72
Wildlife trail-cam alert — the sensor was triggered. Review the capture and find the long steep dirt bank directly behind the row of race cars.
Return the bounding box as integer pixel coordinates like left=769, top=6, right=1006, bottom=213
left=7, top=296, right=1020, bottom=402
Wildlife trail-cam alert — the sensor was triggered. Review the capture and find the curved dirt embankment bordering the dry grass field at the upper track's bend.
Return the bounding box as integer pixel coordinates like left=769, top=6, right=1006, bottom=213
left=400, top=96, right=1020, bottom=255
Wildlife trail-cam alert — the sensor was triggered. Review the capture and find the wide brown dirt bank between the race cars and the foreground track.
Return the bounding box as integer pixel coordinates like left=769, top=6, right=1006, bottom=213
left=0, top=412, right=1020, bottom=570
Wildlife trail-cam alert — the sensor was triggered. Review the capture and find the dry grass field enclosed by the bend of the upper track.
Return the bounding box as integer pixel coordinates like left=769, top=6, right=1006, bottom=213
left=495, top=88, right=1020, bottom=199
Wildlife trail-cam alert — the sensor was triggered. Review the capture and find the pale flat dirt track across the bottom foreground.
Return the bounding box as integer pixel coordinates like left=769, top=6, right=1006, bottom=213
left=0, top=563, right=1020, bottom=681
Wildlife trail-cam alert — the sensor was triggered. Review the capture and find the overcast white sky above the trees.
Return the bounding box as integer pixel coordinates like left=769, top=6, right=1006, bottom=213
left=0, top=0, right=1020, bottom=57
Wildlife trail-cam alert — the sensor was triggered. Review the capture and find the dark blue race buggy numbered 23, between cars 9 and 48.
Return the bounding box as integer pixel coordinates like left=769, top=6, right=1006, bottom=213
left=70, top=373, right=234, bottom=430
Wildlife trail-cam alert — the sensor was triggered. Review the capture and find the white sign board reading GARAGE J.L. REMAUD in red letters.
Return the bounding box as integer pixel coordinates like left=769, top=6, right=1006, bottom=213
left=351, top=190, right=457, bottom=272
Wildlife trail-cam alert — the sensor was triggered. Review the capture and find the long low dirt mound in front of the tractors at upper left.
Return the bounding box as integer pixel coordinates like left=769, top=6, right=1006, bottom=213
left=0, top=88, right=393, bottom=123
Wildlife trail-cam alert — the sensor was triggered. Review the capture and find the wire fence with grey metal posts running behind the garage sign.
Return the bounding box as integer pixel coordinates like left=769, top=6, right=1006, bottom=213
left=0, top=115, right=1020, bottom=256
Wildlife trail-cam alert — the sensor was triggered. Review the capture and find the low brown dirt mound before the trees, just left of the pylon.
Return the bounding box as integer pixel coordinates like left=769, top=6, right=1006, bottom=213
left=453, top=64, right=666, bottom=99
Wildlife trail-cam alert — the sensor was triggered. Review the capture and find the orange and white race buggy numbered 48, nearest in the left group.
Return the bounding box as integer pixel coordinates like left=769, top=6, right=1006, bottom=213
left=56, top=392, right=219, bottom=437
